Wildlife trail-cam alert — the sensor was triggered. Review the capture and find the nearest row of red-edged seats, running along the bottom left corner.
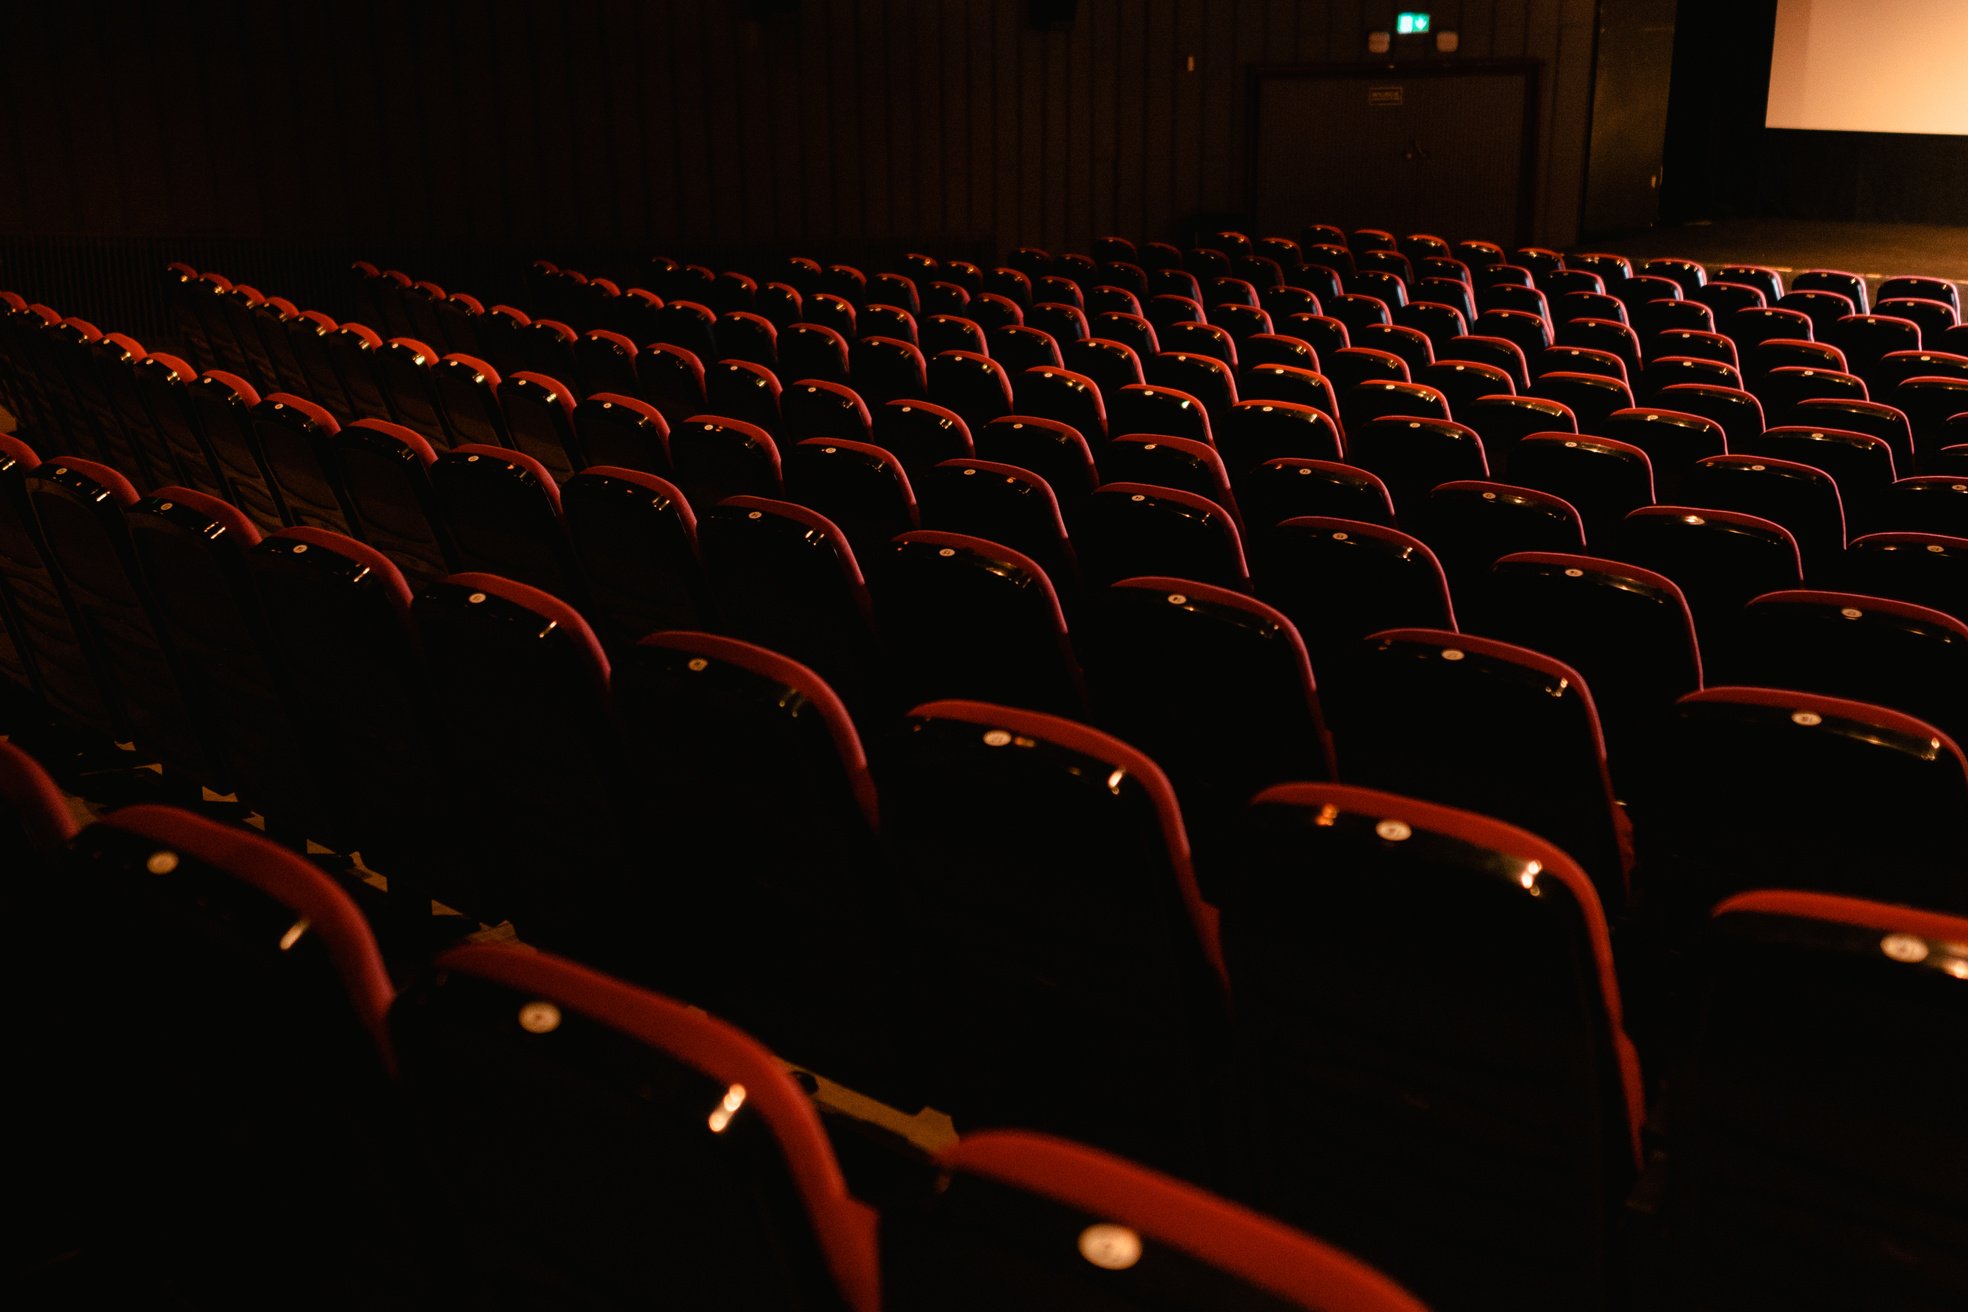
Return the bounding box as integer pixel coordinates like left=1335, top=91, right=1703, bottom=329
left=0, top=771, right=1421, bottom=1312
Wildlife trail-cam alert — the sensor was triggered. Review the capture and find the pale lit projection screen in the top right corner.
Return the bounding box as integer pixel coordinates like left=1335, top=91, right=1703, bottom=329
left=1763, top=0, right=1968, bottom=136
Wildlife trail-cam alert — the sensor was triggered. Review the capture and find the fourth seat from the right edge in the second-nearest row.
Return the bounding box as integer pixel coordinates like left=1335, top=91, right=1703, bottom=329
left=614, top=631, right=921, bottom=1109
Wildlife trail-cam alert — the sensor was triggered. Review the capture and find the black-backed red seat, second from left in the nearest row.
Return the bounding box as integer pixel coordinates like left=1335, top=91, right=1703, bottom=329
left=39, top=806, right=399, bottom=1308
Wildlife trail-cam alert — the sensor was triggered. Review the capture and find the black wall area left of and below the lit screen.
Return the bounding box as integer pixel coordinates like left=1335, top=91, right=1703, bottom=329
left=1661, top=0, right=1968, bottom=224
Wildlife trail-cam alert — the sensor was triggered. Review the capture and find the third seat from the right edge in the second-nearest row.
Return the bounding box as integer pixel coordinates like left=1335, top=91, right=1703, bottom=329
left=882, top=702, right=1226, bottom=1176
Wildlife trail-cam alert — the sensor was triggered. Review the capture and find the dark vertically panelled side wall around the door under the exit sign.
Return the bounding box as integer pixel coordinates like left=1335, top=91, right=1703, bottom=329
left=0, top=0, right=1596, bottom=338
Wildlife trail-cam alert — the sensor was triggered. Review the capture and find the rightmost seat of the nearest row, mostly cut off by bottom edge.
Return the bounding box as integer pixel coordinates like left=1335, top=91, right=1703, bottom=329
left=882, top=1131, right=1421, bottom=1312
